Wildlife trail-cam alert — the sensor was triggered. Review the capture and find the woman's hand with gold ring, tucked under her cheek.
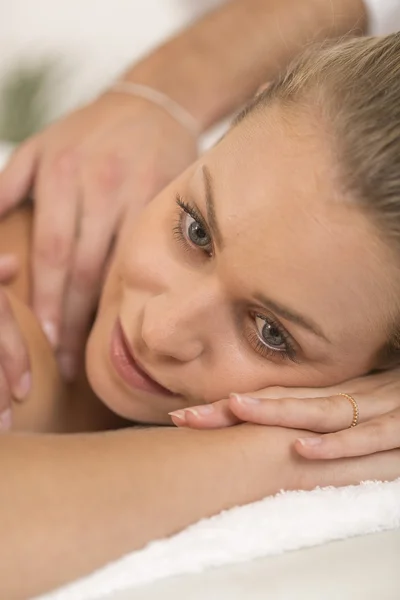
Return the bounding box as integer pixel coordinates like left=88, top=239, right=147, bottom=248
left=171, top=369, right=400, bottom=459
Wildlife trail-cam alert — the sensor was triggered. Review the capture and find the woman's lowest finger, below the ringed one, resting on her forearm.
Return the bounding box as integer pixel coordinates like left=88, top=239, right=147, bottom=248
left=295, top=409, right=400, bottom=460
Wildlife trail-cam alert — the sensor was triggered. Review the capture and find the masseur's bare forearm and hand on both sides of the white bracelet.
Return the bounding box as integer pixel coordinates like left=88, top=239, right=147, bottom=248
left=0, top=0, right=367, bottom=378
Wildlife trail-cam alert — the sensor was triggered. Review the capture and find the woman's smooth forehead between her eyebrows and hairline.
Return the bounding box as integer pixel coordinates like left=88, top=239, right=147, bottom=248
left=193, top=110, right=396, bottom=350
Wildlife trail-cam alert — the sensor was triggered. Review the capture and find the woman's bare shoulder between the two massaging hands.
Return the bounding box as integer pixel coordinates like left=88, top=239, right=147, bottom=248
left=0, top=207, right=121, bottom=433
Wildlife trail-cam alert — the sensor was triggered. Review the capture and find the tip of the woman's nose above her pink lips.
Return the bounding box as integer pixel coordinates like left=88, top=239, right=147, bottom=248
left=142, top=286, right=216, bottom=362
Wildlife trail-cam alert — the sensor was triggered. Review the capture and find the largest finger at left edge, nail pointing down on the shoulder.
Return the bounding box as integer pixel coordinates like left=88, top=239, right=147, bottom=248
left=0, top=289, right=31, bottom=400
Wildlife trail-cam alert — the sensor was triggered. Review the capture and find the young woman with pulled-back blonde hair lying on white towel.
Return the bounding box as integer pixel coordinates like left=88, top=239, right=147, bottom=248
left=0, top=35, right=400, bottom=597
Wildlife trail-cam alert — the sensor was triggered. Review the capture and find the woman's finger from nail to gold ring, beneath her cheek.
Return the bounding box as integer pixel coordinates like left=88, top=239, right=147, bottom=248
left=229, top=390, right=360, bottom=433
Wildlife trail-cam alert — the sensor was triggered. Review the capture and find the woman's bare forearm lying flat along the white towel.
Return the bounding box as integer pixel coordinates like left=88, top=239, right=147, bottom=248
left=0, top=425, right=400, bottom=600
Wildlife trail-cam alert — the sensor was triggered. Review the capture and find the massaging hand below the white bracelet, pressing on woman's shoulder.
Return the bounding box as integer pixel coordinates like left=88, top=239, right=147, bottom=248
left=0, top=93, right=196, bottom=379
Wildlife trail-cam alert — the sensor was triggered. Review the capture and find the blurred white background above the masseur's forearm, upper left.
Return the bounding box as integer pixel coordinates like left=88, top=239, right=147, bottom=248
left=0, top=0, right=222, bottom=116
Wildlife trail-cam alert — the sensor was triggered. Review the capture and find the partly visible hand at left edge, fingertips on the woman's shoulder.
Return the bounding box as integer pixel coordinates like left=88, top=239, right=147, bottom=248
left=0, top=255, right=31, bottom=432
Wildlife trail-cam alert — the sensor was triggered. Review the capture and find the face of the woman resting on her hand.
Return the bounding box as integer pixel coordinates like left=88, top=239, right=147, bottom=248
left=87, top=107, right=395, bottom=423
